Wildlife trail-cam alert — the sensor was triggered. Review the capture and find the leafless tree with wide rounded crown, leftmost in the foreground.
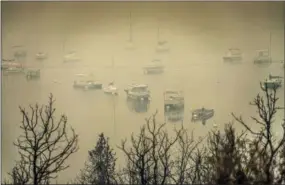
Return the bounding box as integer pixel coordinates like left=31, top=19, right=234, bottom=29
left=12, top=94, right=78, bottom=185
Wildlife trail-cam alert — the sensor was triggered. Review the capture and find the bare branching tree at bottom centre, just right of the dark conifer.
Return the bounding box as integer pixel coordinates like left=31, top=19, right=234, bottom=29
left=119, top=112, right=181, bottom=185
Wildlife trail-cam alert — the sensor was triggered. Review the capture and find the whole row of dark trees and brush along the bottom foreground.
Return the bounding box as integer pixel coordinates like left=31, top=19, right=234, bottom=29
left=2, top=84, right=285, bottom=185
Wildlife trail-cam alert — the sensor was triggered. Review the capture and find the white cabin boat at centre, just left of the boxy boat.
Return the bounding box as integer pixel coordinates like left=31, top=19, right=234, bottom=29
left=124, top=84, right=150, bottom=101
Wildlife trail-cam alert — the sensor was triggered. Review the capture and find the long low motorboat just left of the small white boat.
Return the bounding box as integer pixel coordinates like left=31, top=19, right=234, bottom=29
left=73, top=74, right=102, bottom=90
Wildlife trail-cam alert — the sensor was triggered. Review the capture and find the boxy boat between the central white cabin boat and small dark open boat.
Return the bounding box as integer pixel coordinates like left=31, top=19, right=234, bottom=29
left=164, top=90, right=184, bottom=112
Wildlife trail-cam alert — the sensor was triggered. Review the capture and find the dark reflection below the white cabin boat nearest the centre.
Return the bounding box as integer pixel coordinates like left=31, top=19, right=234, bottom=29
left=127, top=98, right=150, bottom=113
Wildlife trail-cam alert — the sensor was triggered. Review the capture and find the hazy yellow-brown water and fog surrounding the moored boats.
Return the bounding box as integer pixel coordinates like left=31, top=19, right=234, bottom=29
left=2, top=2, right=284, bottom=183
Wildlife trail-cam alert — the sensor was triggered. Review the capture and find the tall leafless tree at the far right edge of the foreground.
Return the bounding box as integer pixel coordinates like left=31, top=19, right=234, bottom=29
left=232, top=85, right=285, bottom=184
